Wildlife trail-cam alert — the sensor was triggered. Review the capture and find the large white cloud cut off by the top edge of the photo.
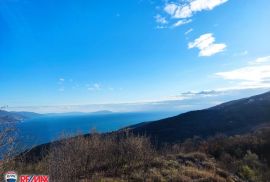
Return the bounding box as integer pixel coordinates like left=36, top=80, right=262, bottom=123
left=164, top=0, right=228, bottom=19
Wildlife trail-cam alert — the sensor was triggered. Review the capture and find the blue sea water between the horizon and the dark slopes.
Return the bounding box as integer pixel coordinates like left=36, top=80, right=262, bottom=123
left=17, top=112, right=179, bottom=148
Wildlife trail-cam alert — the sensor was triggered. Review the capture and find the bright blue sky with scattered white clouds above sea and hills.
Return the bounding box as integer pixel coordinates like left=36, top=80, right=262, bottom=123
left=0, top=0, right=270, bottom=112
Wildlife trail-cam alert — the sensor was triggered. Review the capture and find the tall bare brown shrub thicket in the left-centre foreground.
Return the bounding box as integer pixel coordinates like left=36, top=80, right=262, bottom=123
left=46, top=134, right=155, bottom=181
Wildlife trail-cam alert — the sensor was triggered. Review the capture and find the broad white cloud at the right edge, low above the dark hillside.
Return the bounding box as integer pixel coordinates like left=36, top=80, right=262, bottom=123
left=215, top=56, right=270, bottom=88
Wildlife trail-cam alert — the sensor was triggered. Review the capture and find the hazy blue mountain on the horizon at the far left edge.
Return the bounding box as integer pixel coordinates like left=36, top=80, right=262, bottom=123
left=0, top=110, right=42, bottom=124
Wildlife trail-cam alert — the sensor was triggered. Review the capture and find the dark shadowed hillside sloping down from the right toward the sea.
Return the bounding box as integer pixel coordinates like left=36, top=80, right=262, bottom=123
left=128, top=92, right=270, bottom=143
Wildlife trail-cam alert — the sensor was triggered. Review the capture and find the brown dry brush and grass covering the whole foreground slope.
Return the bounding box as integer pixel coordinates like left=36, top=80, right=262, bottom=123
left=2, top=127, right=270, bottom=182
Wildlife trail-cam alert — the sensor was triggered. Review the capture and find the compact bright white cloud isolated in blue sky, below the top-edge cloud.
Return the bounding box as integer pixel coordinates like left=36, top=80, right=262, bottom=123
left=188, top=33, right=227, bottom=56
